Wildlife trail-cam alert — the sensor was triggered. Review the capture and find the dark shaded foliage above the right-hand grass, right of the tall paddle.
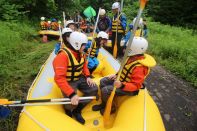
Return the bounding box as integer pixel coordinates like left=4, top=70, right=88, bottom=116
left=148, top=0, right=197, bottom=29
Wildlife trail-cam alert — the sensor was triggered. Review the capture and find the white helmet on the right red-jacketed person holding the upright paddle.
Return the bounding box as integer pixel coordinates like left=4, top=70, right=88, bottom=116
left=127, top=37, right=148, bottom=56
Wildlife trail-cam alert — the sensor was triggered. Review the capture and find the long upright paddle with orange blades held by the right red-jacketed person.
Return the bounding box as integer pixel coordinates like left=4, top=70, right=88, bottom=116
left=103, top=0, right=147, bottom=128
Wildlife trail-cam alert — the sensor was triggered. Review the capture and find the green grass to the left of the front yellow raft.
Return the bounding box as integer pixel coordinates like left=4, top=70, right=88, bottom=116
left=0, top=22, right=55, bottom=131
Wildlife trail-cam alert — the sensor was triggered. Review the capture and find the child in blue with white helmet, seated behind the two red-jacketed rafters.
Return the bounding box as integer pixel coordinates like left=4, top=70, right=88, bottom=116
left=84, top=31, right=109, bottom=74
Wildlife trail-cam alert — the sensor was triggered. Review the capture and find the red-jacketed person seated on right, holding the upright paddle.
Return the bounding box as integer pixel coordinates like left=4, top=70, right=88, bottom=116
left=93, top=37, right=156, bottom=114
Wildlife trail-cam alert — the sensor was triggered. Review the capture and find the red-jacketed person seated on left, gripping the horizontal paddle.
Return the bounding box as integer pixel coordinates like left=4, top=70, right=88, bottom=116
left=53, top=32, right=98, bottom=124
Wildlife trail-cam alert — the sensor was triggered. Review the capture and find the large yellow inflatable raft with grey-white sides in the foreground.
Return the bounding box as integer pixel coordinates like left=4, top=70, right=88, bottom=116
left=17, top=48, right=165, bottom=131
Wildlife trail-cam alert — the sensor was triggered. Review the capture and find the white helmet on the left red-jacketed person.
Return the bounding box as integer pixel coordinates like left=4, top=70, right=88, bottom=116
left=69, top=31, right=88, bottom=51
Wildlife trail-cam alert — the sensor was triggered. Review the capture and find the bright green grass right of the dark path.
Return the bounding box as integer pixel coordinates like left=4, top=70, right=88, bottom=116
left=148, top=22, right=197, bottom=87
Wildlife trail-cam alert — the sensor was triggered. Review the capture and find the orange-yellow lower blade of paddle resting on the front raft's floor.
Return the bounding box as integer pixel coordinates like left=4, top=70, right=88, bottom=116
left=103, top=87, right=116, bottom=128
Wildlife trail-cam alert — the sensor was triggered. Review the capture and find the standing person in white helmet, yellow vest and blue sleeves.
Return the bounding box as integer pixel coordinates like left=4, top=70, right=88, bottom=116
left=111, top=2, right=127, bottom=56
